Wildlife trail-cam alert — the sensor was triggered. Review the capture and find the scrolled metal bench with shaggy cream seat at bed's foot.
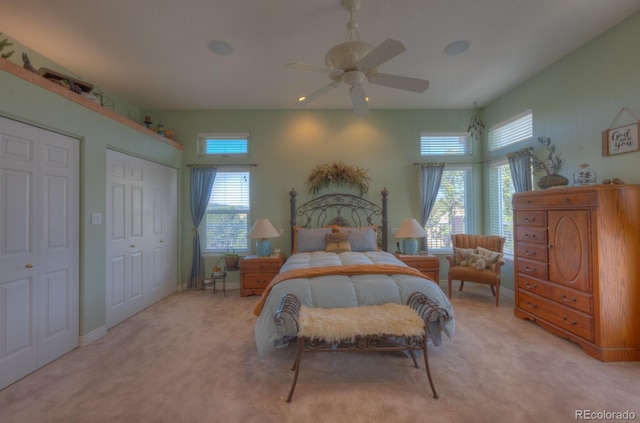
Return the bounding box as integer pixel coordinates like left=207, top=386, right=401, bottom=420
left=275, top=292, right=448, bottom=402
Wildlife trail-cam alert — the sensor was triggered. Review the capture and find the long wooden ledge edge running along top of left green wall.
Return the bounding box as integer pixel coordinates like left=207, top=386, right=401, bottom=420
left=0, top=58, right=182, bottom=150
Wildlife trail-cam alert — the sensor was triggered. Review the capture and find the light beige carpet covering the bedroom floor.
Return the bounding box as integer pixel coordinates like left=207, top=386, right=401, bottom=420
left=0, top=284, right=640, bottom=423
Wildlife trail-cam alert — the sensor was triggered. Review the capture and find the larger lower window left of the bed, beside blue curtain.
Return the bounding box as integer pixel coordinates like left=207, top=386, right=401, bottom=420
left=200, top=169, right=251, bottom=252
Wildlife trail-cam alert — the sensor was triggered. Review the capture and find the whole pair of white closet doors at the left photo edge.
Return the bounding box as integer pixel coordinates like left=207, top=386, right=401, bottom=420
left=0, top=118, right=79, bottom=389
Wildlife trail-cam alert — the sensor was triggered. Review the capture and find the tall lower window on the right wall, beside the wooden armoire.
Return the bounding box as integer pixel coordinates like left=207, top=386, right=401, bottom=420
left=489, top=160, right=515, bottom=254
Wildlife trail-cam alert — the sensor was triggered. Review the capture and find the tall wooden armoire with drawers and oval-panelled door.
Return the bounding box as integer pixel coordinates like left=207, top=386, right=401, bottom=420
left=512, top=185, right=640, bottom=361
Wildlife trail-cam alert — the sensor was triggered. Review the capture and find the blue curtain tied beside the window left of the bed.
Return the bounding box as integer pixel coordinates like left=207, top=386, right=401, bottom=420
left=188, top=167, right=216, bottom=289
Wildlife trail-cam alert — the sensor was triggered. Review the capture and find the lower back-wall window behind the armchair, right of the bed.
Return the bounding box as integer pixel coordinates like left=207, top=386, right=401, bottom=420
left=425, top=165, right=473, bottom=251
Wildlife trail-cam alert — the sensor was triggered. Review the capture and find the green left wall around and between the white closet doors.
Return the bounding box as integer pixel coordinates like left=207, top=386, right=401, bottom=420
left=0, top=72, right=182, bottom=335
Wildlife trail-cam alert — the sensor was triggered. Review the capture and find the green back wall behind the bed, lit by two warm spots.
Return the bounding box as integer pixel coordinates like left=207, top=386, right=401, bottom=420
left=144, top=110, right=481, bottom=286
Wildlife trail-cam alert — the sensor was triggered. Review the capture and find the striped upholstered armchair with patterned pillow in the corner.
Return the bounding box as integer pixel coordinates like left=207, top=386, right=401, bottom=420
left=447, top=234, right=506, bottom=307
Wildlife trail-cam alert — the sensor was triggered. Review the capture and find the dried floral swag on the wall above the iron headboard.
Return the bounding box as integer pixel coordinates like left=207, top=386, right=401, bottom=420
left=307, top=162, right=371, bottom=197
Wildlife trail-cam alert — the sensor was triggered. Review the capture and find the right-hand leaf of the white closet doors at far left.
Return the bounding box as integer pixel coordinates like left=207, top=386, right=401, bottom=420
left=38, top=130, right=80, bottom=366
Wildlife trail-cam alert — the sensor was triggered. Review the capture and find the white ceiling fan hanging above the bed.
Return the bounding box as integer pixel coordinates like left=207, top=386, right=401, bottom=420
left=287, top=0, right=429, bottom=116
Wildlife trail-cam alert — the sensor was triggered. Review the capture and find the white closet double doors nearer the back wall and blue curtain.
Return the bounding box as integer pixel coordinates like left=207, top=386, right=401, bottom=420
left=106, top=151, right=178, bottom=328
